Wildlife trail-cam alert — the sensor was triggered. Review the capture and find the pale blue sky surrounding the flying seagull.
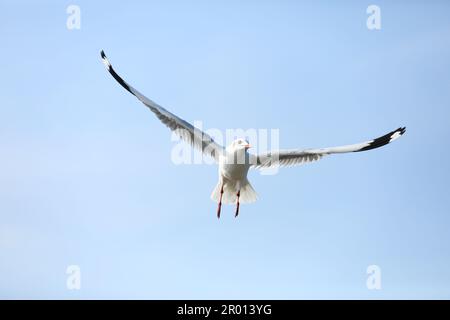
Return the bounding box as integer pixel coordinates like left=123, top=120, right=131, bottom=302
left=0, top=0, right=450, bottom=299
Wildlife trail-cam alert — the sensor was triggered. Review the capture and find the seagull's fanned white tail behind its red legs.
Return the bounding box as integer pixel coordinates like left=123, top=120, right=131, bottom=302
left=211, top=180, right=258, bottom=204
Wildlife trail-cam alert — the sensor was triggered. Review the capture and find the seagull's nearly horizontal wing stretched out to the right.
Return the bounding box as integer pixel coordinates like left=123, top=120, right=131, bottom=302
left=251, top=127, right=406, bottom=169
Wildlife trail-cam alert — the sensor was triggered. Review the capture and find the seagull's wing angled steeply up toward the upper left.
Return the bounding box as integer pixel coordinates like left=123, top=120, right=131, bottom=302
left=101, top=50, right=224, bottom=161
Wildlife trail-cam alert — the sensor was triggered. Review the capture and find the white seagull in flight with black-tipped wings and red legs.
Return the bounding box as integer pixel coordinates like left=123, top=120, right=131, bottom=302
left=100, top=50, right=406, bottom=218
